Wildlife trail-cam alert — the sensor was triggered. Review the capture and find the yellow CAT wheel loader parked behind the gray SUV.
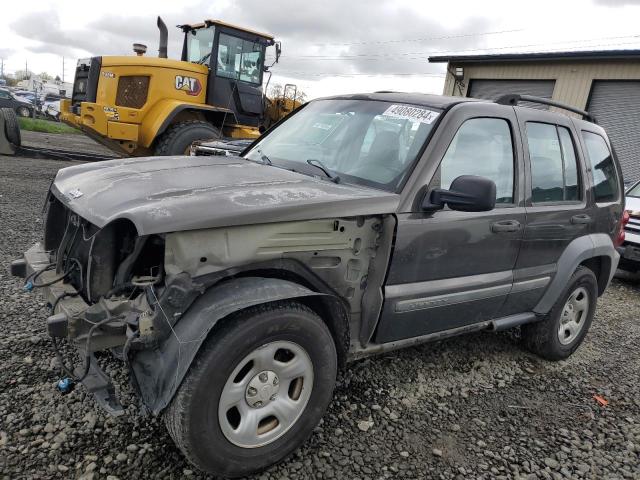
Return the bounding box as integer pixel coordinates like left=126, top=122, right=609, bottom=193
left=60, top=17, right=298, bottom=156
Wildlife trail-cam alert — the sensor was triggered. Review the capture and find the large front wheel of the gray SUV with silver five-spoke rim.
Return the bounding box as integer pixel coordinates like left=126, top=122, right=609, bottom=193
left=165, top=301, right=338, bottom=477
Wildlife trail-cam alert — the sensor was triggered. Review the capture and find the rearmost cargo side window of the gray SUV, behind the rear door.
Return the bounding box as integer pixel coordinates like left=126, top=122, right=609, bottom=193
left=582, top=131, right=618, bottom=202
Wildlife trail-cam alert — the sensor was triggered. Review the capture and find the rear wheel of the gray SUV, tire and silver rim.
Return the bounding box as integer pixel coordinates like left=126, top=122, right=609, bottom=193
left=522, top=267, right=598, bottom=360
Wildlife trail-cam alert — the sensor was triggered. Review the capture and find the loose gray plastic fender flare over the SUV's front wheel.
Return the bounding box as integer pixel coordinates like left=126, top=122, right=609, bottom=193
left=130, top=277, right=339, bottom=415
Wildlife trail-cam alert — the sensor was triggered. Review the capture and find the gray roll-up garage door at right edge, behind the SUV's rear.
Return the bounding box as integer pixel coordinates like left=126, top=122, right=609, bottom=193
left=587, top=80, right=640, bottom=183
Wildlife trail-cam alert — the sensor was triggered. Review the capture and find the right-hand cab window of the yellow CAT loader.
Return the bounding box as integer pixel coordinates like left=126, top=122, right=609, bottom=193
left=216, top=33, right=265, bottom=85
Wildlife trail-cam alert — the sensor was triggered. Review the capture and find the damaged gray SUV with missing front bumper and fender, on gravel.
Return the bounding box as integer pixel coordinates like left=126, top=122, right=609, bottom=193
left=11, top=92, right=624, bottom=476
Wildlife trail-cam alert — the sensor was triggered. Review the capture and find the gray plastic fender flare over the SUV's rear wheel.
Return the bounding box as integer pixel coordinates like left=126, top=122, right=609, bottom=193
left=533, top=233, right=620, bottom=315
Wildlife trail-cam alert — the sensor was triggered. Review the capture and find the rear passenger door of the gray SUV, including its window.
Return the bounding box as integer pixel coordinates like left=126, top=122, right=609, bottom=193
left=501, top=108, right=595, bottom=315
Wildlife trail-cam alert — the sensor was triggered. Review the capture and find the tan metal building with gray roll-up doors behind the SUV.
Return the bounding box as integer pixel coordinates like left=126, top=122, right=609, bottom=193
left=429, top=50, right=640, bottom=182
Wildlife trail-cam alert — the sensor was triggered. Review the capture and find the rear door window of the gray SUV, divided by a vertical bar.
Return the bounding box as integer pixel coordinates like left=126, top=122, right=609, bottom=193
left=527, top=122, right=580, bottom=203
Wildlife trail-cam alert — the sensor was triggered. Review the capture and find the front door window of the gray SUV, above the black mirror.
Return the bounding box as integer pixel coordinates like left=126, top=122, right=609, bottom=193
left=432, top=118, right=514, bottom=203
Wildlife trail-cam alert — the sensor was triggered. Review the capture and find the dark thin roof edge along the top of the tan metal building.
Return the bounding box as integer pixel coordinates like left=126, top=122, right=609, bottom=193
left=429, top=50, right=640, bottom=63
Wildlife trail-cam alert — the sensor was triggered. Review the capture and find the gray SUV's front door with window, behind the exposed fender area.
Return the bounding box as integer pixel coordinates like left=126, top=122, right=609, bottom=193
left=375, top=106, right=525, bottom=343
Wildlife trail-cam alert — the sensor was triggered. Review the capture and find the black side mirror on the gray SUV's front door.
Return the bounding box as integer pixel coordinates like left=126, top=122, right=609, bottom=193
left=422, top=175, right=496, bottom=212
